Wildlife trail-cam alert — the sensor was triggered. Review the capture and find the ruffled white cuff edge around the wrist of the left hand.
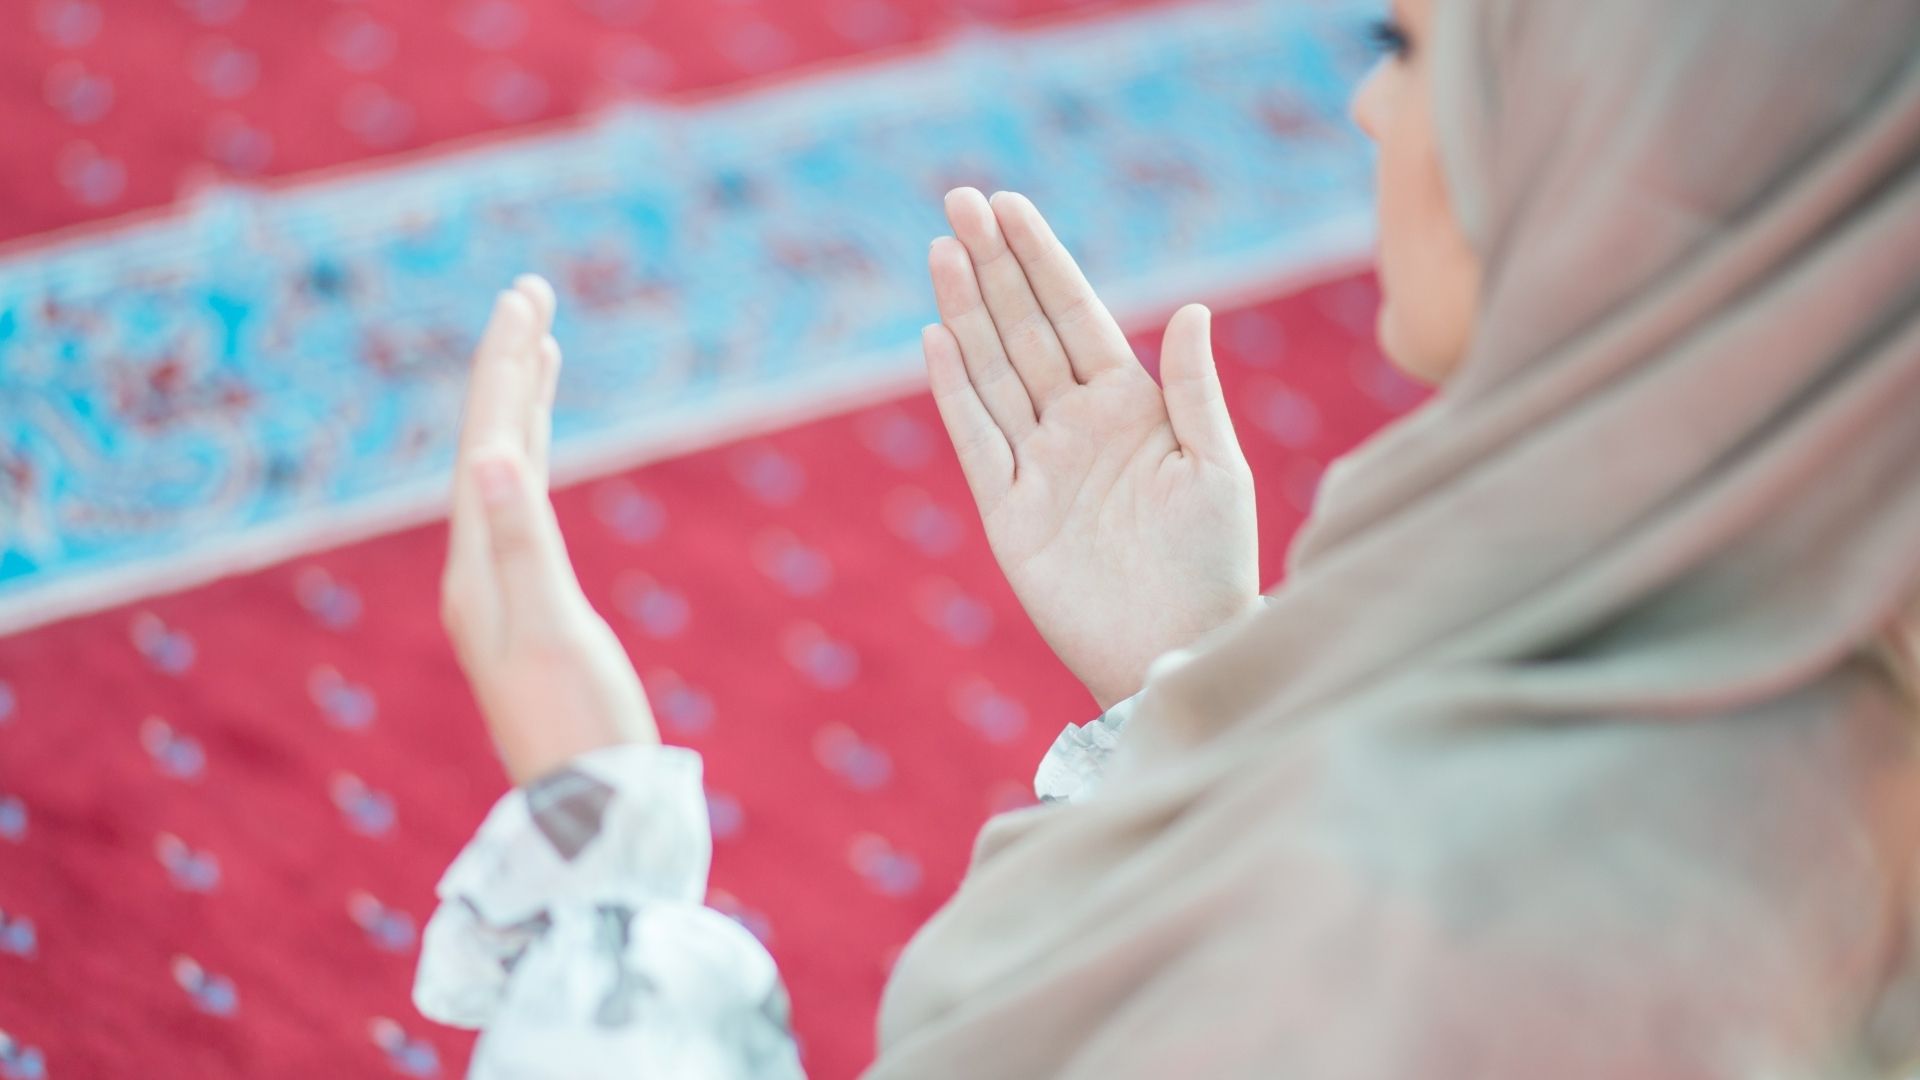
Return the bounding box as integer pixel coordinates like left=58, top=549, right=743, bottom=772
left=413, top=744, right=712, bottom=1028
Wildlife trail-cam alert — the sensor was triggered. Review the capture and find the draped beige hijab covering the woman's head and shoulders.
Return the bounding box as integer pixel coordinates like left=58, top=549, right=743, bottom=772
left=870, top=0, right=1920, bottom=1080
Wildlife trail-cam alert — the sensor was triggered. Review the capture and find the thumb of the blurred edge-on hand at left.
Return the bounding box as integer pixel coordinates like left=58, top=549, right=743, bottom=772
left=472, top=446, right=580, bottom=632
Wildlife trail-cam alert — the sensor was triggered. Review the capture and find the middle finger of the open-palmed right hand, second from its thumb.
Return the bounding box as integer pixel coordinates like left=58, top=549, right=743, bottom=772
left=947, top=188, right=1077, bottom=415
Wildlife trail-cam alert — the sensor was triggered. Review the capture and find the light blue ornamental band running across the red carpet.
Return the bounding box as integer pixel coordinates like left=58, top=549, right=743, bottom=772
left=0, top=0, right=1377, bottom=601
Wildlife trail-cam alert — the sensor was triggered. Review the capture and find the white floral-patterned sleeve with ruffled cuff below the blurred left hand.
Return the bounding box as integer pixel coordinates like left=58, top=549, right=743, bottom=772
left=413, top=744, right=804, bottom=1080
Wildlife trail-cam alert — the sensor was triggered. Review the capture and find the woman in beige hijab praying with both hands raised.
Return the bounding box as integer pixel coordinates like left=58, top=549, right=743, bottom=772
left=419, top=0, right=1920, bottom=1080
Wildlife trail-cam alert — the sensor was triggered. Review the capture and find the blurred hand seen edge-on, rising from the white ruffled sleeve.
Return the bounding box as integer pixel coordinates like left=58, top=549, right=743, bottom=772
left=440, top=275, right=659, bottom=784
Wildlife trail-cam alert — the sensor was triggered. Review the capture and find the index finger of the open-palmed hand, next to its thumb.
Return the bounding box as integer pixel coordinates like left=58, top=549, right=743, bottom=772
left=991, top=192, right=1139, bottom=382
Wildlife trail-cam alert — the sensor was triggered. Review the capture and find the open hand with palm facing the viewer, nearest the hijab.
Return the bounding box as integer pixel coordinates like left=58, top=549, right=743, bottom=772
left=922, top=188, right=1260, bottom=709
